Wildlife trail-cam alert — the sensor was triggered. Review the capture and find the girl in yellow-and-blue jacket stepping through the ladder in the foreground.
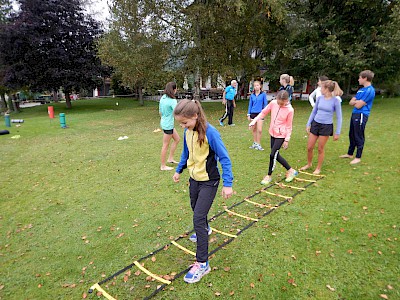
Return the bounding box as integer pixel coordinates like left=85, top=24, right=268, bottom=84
left=173, top=100, right=233, bottom=283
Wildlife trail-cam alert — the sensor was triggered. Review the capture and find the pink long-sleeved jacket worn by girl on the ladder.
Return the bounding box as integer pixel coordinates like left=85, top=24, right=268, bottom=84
left=257, top=100, right=294, bottom=141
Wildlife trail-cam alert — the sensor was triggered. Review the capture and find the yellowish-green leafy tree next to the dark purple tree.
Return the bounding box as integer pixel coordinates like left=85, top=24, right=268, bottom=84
left=99, top=0, right=173, bottom=105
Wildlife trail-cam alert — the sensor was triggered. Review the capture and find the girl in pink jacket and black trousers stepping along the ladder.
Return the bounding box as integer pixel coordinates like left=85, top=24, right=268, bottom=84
left=249, top=91, right=298, bottom=184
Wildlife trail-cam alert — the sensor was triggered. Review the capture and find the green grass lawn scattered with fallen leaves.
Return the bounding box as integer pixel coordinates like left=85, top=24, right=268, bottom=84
left=0, top=98, right=400, bottom=299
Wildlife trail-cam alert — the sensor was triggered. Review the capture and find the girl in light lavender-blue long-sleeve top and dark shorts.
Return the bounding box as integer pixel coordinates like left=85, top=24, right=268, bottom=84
left=300, top=80, right=343, bottom=175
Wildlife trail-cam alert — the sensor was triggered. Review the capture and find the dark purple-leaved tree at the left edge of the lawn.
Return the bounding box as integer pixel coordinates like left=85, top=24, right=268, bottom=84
left=0, top=0, right=103, bottom=108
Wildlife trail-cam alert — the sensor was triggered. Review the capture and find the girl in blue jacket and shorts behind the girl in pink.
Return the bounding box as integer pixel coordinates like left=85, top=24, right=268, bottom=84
left=247, top=80, right=268, bottom=151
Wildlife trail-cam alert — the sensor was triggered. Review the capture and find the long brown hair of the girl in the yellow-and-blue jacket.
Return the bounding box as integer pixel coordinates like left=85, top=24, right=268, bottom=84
left=174, top=99, right=207, bottom=146
